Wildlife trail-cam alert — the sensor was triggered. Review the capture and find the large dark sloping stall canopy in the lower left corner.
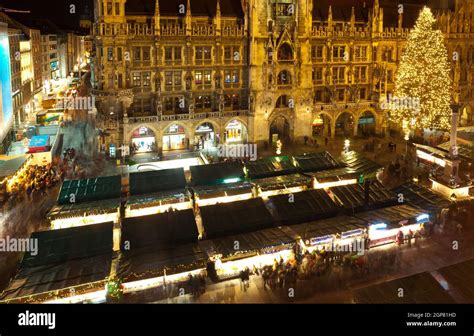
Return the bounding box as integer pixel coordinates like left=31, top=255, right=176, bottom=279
left=2, top=223, right=113, bottom=300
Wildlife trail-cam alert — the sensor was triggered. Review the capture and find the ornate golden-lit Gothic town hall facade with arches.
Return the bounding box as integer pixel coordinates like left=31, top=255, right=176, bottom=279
left=92, top=0, right=474, bottom=150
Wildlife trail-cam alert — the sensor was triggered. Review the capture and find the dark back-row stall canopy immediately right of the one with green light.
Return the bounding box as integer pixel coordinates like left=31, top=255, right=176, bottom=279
left=245, top=156, right=296, bottom=179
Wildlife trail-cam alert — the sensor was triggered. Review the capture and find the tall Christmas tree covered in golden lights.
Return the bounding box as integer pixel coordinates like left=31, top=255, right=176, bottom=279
left=390, top=7, right=452, bottom=131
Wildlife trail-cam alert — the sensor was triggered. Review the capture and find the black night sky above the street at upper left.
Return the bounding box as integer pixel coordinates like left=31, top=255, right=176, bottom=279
left=0, top=0, right=93, bottom=28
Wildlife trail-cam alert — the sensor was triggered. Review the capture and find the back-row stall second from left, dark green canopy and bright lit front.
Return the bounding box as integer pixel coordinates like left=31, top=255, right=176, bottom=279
left=125, top=168, right=192, bottom=217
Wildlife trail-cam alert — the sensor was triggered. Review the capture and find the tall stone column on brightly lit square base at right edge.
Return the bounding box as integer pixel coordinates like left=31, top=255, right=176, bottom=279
left=430, top=104, right=472, bottom=201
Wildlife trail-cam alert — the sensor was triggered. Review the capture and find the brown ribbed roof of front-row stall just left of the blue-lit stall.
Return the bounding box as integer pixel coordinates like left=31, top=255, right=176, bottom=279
left=291, top=216, right=366, bottom=240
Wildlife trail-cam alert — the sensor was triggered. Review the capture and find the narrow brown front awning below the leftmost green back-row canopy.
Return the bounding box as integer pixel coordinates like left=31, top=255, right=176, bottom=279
left=46, top=199, right=120, bottom=220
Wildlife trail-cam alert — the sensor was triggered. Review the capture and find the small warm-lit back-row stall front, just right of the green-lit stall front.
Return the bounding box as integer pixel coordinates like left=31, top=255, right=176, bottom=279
left=252, top=174, right=311, bottom=198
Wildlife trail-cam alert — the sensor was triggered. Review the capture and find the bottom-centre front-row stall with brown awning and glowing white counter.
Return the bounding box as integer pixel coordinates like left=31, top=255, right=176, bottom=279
left=202, top=227, right=296, bottom=280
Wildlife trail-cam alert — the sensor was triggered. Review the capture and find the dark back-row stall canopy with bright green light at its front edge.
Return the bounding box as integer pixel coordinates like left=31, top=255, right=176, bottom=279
left=190, top=162, right=245, bottom=186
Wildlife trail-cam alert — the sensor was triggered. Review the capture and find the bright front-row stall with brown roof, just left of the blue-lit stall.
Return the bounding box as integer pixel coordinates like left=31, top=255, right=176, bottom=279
left=291, top=216, right=367, bottom=252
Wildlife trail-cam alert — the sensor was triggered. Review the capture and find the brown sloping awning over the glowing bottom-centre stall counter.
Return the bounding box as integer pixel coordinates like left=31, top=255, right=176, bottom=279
left=212, top=227, right=297, bottom=258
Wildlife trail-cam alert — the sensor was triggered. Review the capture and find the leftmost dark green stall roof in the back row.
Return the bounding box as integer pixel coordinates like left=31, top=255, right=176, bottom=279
left=58, top=175, right=122, bottom=205
